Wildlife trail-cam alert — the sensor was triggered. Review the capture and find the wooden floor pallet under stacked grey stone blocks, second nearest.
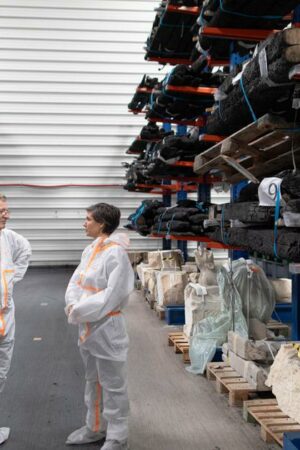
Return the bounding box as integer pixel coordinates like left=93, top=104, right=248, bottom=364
left=206, top=362, right=256, bottom=406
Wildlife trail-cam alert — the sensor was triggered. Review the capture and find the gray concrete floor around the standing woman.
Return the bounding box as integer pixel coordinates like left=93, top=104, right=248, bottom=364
left=0, top=268, right=278, bottom=450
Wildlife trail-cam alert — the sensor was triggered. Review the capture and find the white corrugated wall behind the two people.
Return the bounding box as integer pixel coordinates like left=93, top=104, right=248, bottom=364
left=0, top=0, right=229, bottom=264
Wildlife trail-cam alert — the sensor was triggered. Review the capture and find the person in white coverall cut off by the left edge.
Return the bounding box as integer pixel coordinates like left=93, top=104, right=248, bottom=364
left=0, top=194, right=31, bottom=444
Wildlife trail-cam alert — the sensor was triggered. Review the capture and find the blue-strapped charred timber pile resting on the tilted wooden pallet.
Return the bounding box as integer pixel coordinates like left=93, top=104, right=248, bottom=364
left=207, top=28, right=300, bottom=135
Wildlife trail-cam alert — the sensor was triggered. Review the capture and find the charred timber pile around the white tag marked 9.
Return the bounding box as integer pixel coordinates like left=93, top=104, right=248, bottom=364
left=207, top=170, right=300, bottom=262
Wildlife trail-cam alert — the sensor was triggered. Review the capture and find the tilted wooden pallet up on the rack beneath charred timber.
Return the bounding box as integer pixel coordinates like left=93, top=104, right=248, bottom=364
left=194, top=114, right=300, bottom=183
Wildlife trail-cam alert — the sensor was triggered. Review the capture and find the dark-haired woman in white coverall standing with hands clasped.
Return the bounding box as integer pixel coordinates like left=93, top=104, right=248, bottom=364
left=65, top=203, right=134, bottom=450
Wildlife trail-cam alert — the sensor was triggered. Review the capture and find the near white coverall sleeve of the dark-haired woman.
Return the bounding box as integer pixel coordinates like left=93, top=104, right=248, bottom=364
left=69, top=248, right=134, bottom=324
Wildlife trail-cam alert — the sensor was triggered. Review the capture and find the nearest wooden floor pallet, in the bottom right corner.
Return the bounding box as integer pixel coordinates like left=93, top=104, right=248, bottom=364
left=243, top=399, right=300, bottom=447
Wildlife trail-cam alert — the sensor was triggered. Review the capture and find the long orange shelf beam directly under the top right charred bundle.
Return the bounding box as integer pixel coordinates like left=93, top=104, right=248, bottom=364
left=201, top=27, right=278, bottom=42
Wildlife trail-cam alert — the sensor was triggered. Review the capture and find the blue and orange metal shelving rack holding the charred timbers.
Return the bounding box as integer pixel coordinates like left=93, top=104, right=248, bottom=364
left=126, top=0, right=300, bottom=340
